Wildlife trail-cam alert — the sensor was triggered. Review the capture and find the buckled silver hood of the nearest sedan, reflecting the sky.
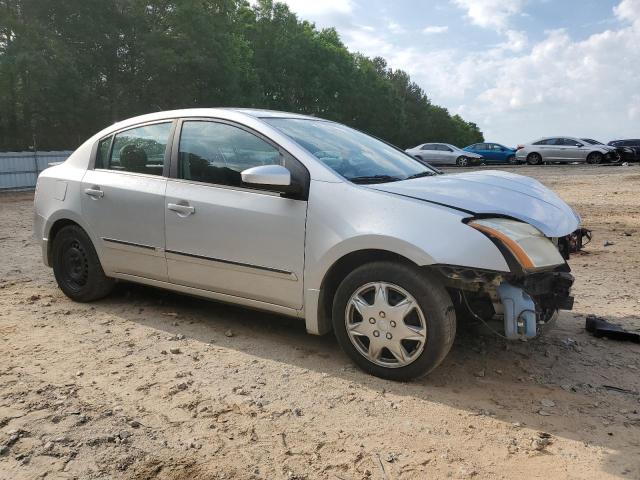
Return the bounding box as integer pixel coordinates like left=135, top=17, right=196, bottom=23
left=368, top=170, right=580, bottom=237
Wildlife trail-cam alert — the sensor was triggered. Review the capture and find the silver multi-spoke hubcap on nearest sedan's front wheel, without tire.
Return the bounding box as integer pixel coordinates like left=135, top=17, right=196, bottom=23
left=345, top=282, right=427, bottom=368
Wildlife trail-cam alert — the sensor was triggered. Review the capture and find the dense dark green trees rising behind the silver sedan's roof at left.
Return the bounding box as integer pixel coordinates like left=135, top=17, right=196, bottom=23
left=0, top=0, right=483, bottom=150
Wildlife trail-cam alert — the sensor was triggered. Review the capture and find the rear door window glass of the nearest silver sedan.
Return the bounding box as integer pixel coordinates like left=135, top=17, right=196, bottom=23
left=106, top=122, right=171, bottom=175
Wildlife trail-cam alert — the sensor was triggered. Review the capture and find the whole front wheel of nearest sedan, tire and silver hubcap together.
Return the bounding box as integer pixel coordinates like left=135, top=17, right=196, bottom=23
left=332, top=262, right=456, bottom=380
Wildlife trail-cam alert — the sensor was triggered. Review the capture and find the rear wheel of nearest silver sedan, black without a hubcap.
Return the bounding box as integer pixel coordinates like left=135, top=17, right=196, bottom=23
left=52, top=225, right=115, bottom=302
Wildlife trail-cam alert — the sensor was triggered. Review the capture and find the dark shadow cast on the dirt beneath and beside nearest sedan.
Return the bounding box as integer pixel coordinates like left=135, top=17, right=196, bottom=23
left=93, top=283, right=640, bottom=478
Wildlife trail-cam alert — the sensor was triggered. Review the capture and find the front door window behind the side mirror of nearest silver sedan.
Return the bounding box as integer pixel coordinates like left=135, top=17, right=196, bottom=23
left=178, top=120, right=282, bottom=187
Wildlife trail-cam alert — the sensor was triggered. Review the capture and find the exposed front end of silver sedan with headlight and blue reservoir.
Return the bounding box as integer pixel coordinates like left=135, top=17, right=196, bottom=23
left=437, top=218, right=574, bottom=340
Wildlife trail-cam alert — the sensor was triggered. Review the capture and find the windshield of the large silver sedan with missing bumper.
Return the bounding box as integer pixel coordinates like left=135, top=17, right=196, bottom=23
left=263, top=118, right=436, bottom=183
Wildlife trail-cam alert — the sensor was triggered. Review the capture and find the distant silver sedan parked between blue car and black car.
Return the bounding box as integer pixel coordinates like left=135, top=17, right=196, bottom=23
left=516, top=137, right=620, bottom=165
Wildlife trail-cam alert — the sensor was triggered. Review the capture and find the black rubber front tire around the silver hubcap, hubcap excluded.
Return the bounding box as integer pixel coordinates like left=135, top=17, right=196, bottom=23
left=332, top=261, right=456, bottom=380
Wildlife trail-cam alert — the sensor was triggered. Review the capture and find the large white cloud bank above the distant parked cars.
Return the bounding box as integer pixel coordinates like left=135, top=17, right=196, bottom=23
left=262, top=0, right=640, bottom=145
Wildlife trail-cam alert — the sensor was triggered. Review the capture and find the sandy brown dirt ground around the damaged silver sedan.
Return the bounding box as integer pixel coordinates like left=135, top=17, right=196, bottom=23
left=0, top=166, right=640, bottom=480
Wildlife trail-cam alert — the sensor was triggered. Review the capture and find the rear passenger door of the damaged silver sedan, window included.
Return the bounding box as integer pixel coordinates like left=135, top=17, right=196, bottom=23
left=82, top=121, right=173, bottom=281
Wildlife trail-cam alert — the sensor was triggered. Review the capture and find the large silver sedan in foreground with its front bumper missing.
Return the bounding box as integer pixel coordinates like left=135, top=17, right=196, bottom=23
left=34, top=109, right=580, bottom=379
